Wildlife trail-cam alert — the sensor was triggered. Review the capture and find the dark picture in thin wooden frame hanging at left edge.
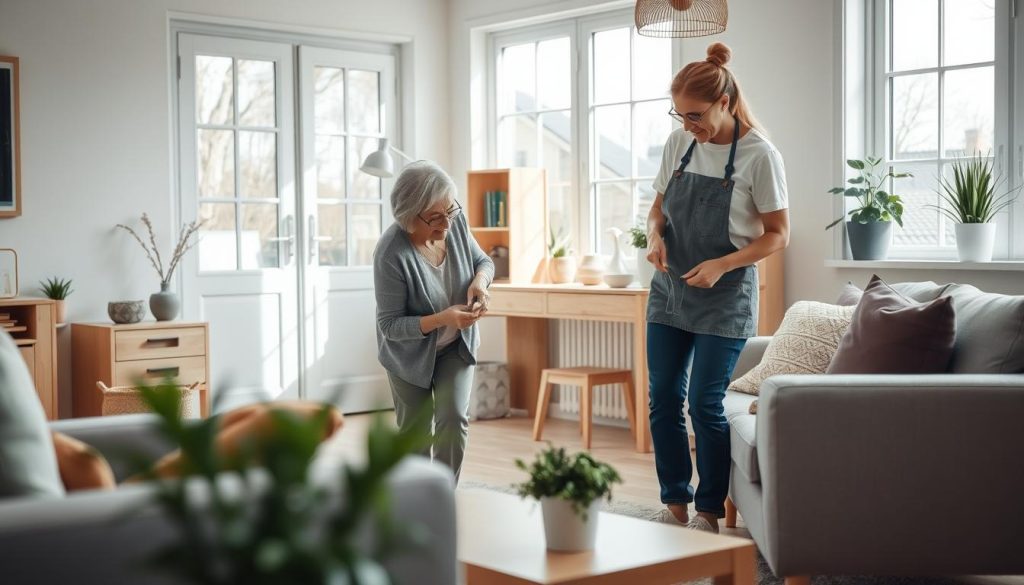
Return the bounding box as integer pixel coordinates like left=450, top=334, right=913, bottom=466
left=0, top=56, right=22, bottom=219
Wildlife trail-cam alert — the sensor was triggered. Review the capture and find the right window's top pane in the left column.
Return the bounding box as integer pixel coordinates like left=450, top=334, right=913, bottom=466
left=892, top=0, right=939, bottom=71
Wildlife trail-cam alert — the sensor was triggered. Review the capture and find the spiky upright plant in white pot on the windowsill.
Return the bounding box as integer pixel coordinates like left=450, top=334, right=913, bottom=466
left=929, top=154, right=1016, bottom=262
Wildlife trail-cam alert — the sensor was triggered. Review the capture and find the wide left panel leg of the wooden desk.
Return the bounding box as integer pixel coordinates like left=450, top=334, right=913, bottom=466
left=505, top=317, right=548, bottom=416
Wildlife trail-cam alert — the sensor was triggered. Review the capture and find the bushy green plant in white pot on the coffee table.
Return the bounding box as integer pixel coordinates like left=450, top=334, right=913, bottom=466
left=514, top=444, right=622, bottom=550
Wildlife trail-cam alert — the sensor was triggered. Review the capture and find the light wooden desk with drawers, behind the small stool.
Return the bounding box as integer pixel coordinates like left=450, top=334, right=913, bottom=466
left=487, top=284, right=651, bottom=453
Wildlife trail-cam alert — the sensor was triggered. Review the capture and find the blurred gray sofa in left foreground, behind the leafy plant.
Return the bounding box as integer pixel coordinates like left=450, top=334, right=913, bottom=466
left=0, top=415, right=457, bottom=585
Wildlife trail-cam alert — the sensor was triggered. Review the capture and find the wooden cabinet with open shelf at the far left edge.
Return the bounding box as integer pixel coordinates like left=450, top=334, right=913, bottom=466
left=0, top=298, right=59, bottom=420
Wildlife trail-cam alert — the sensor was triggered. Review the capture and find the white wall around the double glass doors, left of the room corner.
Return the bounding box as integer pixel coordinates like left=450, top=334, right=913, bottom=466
left=0, top=0, right=451, bottom=416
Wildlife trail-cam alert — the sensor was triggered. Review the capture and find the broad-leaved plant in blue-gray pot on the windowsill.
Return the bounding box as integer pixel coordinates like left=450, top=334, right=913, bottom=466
left=825, top=157, right=913, bottom=260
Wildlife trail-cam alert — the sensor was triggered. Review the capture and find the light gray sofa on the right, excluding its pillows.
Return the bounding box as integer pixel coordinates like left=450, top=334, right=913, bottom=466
left=725, top=337, right=1024, bottom=585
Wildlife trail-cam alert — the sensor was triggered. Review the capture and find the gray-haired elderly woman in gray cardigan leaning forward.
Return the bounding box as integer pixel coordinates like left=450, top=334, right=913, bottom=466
left=374, top=161, right=495, bottom=482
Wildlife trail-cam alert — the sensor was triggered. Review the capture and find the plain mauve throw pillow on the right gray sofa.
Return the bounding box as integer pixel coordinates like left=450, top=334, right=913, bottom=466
left=826, top=277, right=956, bottom=374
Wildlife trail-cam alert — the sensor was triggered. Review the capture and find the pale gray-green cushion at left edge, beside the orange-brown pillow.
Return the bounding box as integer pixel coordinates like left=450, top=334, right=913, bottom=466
left=0, top=331, right=65, bottom=498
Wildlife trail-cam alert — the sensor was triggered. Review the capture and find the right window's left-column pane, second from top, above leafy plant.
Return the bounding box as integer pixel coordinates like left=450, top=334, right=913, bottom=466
left=891, top=73, right=939, bottom=159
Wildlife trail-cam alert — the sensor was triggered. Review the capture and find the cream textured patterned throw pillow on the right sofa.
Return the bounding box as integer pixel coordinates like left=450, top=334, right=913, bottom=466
left=729, top=300, right=856, bottom=395
